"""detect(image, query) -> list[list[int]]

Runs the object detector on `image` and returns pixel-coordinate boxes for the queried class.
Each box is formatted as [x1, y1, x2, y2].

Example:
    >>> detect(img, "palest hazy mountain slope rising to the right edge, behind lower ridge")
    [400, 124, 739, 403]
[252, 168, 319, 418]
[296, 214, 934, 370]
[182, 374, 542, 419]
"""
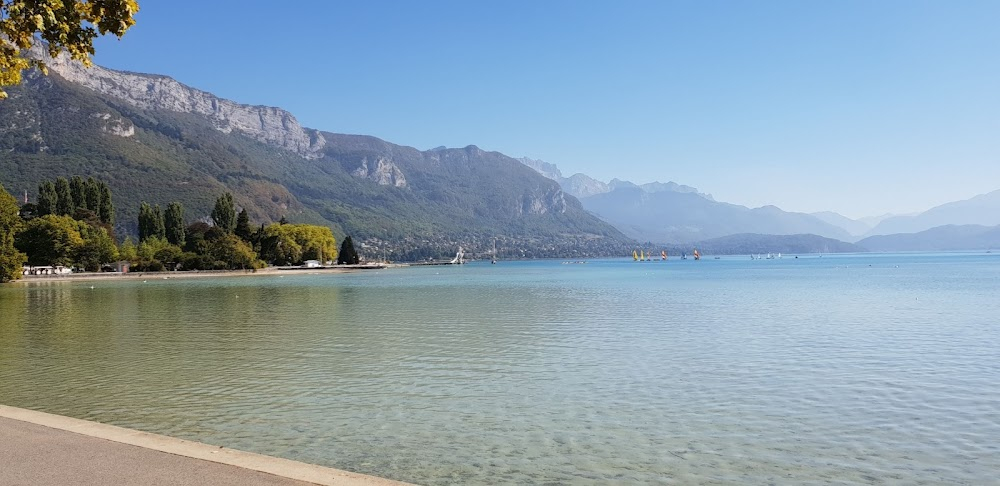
[868, 190, 1000, 236]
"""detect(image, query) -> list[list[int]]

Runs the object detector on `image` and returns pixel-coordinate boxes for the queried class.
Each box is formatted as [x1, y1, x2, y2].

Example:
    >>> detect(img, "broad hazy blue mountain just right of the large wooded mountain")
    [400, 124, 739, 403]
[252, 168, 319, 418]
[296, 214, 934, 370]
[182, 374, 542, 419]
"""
[580, 187, 851, 243]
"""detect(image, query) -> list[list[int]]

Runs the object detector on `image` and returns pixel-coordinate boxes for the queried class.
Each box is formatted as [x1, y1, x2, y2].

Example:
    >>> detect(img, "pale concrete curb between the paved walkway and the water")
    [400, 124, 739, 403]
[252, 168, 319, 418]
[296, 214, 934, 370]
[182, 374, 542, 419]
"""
[0, 405, 408, 486]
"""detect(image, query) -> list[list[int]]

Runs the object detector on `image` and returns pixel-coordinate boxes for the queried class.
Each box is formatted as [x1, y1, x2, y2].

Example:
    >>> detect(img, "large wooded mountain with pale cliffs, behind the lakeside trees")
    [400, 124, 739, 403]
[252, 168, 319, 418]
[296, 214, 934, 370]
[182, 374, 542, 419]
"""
[0, 43, 629, 259]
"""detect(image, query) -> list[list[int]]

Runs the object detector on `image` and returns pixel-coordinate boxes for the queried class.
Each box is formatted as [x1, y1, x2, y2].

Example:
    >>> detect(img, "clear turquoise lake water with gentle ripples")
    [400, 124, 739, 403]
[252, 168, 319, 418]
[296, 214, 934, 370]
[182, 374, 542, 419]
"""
[0, 254, 1000, 484]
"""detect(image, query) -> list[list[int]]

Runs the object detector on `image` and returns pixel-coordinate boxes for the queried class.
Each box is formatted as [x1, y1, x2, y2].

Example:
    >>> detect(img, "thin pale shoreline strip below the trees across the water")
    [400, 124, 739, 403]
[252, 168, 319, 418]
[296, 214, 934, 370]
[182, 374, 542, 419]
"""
[8, 263, 398, 284]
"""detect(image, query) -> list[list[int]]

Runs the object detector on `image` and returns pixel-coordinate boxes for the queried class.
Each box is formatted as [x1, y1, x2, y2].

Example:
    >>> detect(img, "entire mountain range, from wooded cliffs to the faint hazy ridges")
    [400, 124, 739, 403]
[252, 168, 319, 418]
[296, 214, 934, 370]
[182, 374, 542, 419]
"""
[0, 46, 1000, 259]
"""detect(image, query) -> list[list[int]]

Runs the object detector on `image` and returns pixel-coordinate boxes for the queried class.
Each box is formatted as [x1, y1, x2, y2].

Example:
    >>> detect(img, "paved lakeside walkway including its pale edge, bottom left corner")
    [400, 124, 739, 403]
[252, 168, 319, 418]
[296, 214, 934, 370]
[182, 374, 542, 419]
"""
[0, 405, 412, 486]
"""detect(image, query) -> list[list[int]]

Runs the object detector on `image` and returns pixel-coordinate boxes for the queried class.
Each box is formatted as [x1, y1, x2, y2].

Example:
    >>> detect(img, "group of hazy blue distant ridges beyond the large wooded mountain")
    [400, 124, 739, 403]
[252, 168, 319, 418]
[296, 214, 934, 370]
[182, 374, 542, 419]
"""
[519, 158, 1000, 251]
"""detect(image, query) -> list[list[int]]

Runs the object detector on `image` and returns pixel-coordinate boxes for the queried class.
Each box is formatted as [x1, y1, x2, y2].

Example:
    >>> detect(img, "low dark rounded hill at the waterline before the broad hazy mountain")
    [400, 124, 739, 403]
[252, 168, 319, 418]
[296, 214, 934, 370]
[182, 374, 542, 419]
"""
[693, 233, 865, 255]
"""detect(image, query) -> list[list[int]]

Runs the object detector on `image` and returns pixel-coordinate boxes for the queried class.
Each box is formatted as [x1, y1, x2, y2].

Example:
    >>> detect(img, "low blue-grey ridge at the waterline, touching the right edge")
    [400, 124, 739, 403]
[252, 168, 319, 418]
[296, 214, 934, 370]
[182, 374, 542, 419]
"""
[857, 224, 1000, 251]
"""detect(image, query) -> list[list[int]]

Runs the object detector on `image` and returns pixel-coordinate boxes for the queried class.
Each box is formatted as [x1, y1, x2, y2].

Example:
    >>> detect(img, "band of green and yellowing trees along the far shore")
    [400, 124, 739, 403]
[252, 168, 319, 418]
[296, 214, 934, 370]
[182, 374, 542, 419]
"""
[0, 177, 359, 282]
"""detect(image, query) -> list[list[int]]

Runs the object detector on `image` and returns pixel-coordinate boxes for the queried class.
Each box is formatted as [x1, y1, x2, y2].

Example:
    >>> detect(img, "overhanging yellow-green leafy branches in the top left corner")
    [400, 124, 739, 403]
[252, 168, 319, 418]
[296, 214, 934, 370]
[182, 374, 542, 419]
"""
[0, 0, 139, 99]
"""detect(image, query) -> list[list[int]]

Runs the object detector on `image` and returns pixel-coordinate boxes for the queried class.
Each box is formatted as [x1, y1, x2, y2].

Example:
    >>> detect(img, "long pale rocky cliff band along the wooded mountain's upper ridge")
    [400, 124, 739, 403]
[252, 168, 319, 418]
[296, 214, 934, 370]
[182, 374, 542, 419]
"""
[31, 45, 326, 159]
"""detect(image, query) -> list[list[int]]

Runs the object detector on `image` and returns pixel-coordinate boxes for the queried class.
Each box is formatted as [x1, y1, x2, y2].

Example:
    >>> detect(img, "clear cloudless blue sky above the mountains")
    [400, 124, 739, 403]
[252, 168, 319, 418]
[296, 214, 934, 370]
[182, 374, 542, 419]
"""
[95, 0, 1000, 217]
